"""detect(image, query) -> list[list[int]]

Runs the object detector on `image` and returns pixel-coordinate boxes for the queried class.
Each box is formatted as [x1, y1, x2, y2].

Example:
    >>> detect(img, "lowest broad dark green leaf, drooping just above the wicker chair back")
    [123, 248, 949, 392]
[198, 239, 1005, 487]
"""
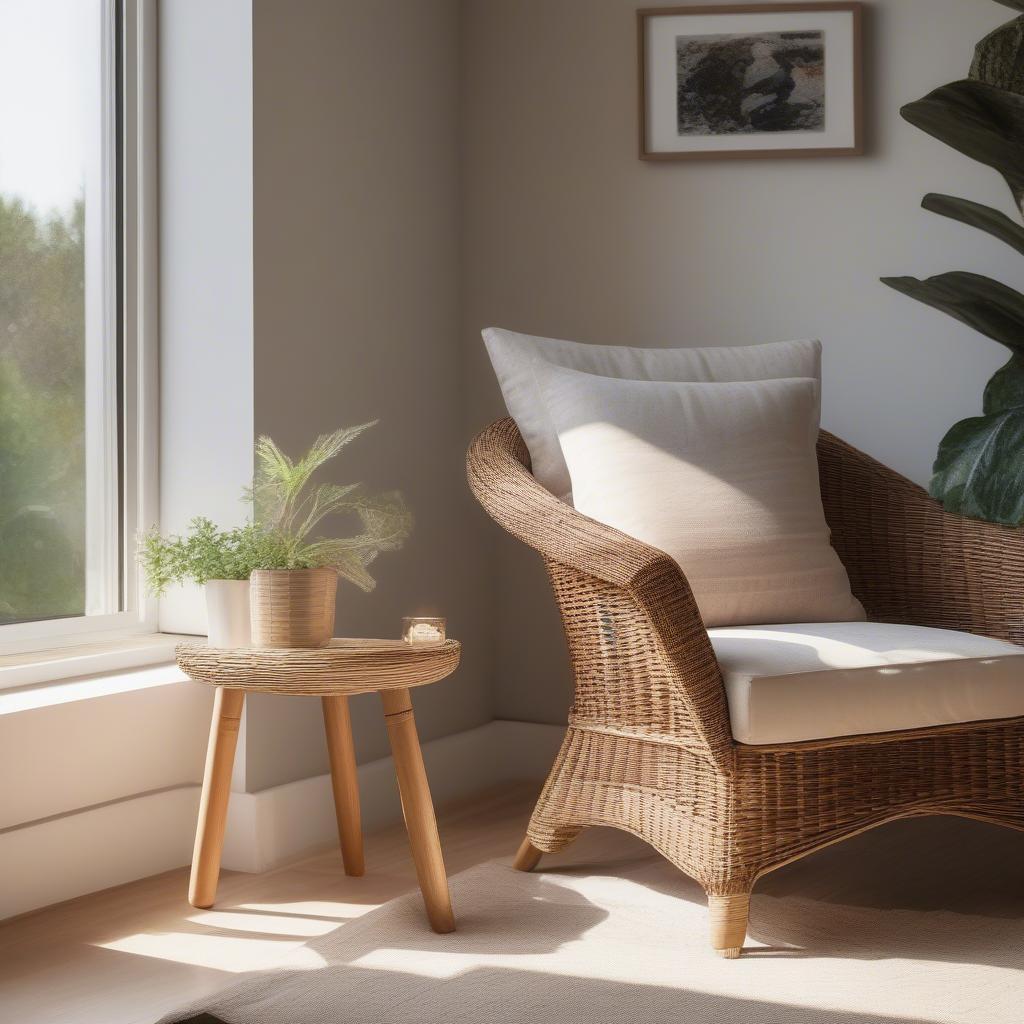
[930, 409, 1024, 526]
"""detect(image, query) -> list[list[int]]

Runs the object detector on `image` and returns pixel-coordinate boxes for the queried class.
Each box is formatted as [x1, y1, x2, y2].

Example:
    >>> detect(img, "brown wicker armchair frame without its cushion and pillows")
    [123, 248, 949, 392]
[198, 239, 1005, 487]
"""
[467, 420, 1024, 957]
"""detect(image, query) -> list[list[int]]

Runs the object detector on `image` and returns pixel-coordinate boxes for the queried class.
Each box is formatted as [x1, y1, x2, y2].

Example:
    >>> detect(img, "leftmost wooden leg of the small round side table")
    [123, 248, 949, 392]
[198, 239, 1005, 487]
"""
[188, 686, 246, 909]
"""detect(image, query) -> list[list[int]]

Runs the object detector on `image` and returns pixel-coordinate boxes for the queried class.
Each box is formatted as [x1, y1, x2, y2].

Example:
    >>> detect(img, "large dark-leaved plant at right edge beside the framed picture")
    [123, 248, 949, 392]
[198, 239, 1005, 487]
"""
[882, 0, 1024, 526]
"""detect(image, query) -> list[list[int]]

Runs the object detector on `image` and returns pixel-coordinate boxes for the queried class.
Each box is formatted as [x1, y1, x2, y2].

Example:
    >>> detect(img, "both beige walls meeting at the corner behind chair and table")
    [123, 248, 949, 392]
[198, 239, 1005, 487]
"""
[201, 0, 1013, 761]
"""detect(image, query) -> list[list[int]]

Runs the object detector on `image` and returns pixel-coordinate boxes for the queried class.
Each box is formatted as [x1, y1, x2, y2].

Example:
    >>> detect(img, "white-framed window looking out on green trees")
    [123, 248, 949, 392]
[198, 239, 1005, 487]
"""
[0, 0, 155, 653]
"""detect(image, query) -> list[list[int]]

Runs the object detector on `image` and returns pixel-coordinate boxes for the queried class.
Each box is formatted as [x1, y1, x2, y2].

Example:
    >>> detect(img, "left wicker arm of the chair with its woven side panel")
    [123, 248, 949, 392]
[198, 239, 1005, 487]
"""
[466, 420, 733, 770]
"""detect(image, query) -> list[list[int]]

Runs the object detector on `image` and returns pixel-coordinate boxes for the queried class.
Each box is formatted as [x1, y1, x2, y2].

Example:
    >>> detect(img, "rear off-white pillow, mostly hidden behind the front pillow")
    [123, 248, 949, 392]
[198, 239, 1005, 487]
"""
[482, 327, 821, 501]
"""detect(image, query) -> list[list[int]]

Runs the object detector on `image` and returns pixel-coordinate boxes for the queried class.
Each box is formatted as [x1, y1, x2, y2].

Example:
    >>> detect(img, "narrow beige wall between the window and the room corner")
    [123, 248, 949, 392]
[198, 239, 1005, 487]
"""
[246, 0, 493, 791]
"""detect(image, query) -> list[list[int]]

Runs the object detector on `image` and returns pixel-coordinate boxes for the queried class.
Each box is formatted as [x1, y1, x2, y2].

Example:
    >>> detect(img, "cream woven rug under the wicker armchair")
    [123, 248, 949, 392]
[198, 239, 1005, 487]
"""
[165, 819, 1024, 1024]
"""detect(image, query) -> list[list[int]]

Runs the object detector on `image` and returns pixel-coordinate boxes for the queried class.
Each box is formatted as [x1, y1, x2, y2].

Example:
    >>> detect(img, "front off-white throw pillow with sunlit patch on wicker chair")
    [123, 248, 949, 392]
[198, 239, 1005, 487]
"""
[536, 365, 864, 627]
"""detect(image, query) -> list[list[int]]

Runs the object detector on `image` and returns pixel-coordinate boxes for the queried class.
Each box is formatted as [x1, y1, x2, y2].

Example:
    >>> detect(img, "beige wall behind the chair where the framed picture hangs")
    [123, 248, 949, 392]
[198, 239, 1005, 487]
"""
[462, 0, 1017, 722]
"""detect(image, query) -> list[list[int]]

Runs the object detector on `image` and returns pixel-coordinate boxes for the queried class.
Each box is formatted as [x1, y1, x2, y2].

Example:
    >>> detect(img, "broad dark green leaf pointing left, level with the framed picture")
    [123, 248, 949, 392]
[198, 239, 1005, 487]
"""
[900, 79, 1024, 206]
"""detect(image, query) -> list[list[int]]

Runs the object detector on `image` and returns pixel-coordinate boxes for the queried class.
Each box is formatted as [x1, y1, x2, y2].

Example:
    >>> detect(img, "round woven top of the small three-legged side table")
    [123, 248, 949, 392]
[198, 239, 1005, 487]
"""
[175, 637, 462, 696]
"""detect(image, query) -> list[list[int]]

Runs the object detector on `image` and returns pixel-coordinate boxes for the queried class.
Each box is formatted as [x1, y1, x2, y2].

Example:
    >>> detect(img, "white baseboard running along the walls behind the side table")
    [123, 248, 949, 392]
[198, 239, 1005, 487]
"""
[0, 721, 565, 920]
